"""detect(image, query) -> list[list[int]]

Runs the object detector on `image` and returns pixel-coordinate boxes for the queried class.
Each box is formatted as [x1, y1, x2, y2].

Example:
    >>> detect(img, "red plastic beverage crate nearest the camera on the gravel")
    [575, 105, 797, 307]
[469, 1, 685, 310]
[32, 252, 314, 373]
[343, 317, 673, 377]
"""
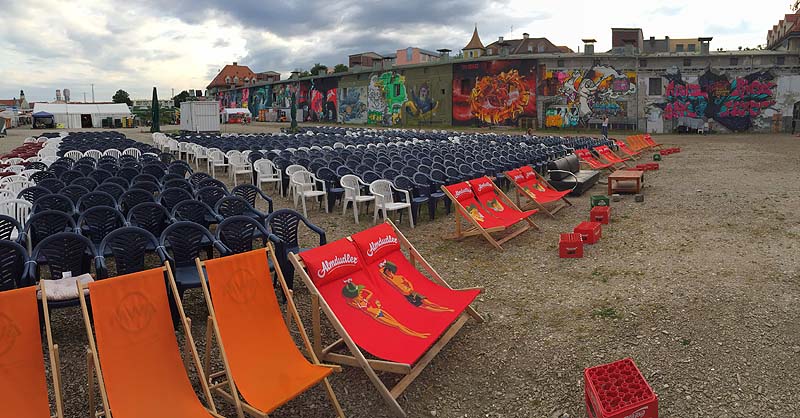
[583, 358, 658, 418]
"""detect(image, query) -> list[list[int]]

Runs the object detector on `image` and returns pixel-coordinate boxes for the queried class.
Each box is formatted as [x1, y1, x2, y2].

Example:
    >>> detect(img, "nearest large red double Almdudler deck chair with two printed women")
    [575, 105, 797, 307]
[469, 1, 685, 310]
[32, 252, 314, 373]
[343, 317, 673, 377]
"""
[289, 221, 483, 417]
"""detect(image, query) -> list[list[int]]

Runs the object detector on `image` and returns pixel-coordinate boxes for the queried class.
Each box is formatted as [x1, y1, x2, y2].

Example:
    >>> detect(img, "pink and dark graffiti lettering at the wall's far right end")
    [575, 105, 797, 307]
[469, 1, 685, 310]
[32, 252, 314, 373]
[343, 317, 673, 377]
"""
[657, 70, 777, 131]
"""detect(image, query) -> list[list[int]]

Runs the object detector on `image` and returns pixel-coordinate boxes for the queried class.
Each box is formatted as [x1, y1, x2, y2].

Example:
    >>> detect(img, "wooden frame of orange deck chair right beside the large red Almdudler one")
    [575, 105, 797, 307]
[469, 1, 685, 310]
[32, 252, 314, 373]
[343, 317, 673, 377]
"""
[195, 243, 345, 418]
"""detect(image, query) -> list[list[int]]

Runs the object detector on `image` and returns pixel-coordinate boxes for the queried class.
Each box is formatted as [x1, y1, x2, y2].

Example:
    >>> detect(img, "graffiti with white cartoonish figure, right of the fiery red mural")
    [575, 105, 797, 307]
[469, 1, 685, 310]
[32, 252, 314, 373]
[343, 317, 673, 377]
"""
[542, 66, 636, 128]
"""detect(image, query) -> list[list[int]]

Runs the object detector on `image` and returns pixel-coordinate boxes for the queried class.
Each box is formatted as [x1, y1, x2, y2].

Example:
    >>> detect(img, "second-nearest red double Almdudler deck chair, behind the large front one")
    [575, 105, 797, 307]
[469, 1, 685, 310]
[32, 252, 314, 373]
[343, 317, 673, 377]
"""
[442, 182, 530, 251]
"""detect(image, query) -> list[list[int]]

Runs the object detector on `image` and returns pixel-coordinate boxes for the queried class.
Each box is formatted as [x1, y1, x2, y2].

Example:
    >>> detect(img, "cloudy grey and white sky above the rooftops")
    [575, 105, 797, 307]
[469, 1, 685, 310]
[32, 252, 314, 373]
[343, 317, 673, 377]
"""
[0, 0, 790, 101]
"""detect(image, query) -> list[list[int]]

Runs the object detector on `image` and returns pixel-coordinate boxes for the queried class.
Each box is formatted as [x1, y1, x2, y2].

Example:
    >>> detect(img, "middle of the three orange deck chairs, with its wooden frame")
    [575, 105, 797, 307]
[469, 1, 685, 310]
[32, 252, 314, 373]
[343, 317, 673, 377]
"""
[78, 263, 221, 418]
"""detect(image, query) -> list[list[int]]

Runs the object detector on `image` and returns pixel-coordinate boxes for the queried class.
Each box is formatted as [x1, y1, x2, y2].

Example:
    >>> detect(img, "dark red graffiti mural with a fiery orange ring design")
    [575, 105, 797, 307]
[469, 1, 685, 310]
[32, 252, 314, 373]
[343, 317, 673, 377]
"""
[453, 60, 536, 126]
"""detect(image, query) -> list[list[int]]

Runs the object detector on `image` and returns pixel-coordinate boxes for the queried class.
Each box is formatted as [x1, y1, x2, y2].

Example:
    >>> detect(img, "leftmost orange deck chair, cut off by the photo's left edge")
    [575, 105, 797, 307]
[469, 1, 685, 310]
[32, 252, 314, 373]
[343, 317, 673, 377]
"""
[0, 280, 64, 418]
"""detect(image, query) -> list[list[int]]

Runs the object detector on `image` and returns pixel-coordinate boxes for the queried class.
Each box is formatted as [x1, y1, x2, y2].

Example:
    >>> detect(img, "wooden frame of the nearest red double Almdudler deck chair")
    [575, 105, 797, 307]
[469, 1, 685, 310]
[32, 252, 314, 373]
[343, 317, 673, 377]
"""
[289, 220, 483, 417]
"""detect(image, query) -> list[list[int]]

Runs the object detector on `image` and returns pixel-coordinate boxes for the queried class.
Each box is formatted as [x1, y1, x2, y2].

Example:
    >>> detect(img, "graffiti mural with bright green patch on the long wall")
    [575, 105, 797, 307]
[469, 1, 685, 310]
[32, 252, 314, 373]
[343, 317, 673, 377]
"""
[367, 71, 408, 125]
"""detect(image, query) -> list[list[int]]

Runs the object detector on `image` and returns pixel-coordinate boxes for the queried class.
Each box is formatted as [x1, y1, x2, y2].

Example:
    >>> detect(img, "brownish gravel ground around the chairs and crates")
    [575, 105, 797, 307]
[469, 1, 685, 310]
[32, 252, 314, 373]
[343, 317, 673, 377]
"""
[0, 126, 800, 417]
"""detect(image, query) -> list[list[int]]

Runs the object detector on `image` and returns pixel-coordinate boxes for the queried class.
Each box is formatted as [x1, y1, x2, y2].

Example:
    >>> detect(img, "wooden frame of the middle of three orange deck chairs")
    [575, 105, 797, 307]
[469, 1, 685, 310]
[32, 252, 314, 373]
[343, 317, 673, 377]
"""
[77, 261, 225, 418]
